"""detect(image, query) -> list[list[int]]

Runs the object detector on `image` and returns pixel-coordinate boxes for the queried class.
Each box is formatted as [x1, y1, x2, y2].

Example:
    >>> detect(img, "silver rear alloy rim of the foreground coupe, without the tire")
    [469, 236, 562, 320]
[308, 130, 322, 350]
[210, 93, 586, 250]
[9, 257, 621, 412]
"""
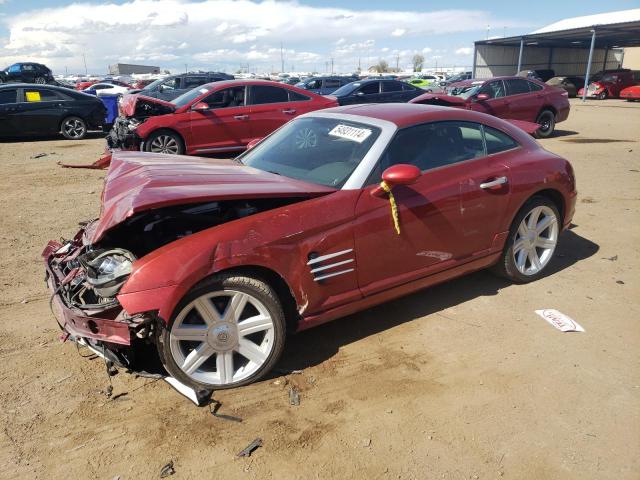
[513, 205, 559, 276]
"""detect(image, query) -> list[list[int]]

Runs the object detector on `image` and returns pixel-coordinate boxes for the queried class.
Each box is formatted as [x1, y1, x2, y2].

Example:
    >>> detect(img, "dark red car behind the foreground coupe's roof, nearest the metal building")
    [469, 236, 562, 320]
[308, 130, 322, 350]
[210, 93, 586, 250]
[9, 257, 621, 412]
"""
[409, 77, 570, 138]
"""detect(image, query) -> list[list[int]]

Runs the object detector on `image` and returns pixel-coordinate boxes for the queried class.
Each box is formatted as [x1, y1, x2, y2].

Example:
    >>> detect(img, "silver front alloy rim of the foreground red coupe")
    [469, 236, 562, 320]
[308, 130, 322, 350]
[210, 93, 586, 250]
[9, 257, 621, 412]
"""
[169, 290, 275, 385]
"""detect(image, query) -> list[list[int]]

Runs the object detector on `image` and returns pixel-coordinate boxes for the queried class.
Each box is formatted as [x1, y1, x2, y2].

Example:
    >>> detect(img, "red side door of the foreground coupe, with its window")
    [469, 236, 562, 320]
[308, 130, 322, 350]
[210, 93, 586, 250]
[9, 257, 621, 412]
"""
[354, 121, 509, 296]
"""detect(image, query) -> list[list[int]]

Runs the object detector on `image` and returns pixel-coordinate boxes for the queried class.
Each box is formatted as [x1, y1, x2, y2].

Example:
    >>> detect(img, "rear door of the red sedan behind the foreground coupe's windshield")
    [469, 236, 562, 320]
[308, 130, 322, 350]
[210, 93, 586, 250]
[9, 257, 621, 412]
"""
[249, 85, 296, 137]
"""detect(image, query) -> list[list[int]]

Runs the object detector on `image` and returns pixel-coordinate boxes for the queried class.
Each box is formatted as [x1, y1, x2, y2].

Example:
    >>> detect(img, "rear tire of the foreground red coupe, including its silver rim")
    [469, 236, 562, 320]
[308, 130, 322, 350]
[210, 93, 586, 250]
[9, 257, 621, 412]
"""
[493, 196, 561, 283]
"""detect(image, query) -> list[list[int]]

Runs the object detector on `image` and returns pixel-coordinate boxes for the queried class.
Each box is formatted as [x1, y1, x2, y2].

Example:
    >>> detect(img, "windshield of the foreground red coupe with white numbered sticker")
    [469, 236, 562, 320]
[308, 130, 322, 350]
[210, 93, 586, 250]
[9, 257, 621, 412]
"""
[238, 117, 380, 188]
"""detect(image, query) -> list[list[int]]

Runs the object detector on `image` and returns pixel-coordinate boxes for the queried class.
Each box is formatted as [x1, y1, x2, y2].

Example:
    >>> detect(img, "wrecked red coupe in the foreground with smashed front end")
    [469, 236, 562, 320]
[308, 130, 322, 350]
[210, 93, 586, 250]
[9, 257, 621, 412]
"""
[43, 104, 576, 389]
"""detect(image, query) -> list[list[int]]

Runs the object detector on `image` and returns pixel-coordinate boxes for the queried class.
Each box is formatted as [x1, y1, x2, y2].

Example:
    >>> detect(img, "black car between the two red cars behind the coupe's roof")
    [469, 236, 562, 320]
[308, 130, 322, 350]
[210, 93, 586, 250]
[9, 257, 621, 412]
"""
[332, 79, 424, 105]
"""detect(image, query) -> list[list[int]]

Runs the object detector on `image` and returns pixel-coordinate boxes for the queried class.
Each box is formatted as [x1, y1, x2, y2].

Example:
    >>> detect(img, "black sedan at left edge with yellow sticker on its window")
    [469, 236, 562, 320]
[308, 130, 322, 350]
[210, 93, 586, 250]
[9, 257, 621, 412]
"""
[0, 83, 106, 140]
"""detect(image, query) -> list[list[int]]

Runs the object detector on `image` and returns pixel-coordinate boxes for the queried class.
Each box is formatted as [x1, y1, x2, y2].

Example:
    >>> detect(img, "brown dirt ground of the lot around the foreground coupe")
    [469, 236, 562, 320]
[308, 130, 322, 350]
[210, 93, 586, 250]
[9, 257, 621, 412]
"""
[0, 100, 640, 480]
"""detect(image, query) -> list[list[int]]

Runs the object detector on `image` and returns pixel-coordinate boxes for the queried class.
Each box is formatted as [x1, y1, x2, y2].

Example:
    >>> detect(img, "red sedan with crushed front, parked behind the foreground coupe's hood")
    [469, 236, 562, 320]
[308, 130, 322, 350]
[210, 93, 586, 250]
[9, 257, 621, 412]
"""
[107, 80, 338, 155]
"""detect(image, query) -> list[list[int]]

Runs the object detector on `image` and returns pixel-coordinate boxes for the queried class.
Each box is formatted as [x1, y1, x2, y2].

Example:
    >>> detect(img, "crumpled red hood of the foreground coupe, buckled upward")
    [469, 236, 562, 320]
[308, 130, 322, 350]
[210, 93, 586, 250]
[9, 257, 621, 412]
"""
[87, 152, 335, 243]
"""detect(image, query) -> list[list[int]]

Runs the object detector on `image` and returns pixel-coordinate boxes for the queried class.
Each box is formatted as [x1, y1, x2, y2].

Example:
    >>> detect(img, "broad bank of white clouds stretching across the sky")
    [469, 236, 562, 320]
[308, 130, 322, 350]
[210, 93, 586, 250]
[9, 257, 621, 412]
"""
[0, 0, 519, 72]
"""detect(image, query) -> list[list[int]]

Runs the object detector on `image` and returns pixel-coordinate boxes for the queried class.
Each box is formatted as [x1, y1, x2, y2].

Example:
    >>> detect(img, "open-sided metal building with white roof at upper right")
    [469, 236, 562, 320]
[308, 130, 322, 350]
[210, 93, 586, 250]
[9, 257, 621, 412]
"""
[473, 8, 640, 96]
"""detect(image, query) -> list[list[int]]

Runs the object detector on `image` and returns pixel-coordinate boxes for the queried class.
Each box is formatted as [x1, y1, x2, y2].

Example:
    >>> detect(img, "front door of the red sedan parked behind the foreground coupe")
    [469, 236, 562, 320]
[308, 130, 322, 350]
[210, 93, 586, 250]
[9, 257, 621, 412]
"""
[182, 85, 254, 153]
